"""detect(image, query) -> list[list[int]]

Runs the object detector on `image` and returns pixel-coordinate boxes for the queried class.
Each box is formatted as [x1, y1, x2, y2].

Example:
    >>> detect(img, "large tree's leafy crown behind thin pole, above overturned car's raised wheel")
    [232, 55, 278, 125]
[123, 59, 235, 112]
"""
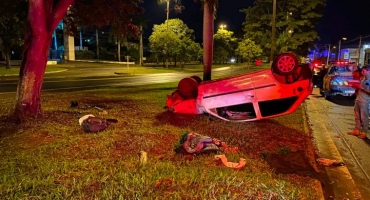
[241, 0, 326, 59]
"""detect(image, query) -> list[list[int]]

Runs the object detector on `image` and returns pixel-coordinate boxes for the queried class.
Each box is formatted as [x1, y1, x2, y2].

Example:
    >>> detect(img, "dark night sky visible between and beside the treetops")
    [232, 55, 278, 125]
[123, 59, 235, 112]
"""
[142, 0, 370, 44]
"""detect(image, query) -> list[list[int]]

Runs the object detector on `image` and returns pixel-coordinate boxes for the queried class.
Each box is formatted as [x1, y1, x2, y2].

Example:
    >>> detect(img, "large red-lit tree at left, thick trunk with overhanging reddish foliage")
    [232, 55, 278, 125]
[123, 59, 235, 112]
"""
[14, 0, 141, 120]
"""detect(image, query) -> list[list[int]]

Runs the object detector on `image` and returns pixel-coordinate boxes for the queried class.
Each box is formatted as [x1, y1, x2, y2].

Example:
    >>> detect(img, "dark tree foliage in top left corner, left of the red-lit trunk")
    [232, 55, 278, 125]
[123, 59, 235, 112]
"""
[0, 0, 27, 69]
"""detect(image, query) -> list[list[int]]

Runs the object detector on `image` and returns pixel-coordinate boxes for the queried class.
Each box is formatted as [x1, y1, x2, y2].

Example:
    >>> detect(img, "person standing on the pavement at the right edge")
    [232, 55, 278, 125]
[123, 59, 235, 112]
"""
[348, 66, 370, 139]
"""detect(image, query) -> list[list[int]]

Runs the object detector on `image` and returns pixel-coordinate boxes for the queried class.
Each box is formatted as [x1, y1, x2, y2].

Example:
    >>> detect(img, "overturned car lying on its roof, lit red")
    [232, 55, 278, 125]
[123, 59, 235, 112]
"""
[166, 53, 313, 122]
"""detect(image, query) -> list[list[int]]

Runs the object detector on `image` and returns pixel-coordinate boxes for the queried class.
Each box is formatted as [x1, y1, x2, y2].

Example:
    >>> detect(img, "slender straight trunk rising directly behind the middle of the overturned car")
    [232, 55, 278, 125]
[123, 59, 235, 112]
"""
[203, 1, 214, 81]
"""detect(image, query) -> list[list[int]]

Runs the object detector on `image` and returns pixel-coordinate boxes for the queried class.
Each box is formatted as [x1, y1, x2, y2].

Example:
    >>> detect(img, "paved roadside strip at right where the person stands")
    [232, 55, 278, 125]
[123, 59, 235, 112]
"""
[306, 88, 370, 200]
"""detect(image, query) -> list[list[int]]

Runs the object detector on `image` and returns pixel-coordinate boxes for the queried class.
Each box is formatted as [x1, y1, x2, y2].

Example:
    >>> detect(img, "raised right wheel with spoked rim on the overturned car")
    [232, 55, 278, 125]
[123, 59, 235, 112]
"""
[272, 53, 299, 76]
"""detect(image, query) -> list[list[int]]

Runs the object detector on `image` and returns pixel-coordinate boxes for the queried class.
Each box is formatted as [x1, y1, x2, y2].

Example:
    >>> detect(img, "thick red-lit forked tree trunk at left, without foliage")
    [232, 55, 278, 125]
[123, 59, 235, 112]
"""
[14, 0, 74, 121]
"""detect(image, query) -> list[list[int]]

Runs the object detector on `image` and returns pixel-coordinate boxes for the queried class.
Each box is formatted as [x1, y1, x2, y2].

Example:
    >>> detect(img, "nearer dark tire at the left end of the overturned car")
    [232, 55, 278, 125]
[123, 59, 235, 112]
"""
[177, 77, 198, 99]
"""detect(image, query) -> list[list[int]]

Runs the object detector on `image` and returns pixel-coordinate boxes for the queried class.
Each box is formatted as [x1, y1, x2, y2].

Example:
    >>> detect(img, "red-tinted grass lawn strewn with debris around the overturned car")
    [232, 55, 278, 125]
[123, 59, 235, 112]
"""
[0, 83, 321, 200]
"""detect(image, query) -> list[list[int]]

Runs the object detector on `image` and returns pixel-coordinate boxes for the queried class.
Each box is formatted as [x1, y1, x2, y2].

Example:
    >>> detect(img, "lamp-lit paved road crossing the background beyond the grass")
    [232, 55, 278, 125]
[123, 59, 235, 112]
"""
[0, 67, 246, 94]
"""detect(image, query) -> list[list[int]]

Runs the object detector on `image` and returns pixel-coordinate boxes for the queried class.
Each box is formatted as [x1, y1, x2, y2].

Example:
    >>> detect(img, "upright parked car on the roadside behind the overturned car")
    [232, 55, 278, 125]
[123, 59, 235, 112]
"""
[320, 61, 360, 100]
